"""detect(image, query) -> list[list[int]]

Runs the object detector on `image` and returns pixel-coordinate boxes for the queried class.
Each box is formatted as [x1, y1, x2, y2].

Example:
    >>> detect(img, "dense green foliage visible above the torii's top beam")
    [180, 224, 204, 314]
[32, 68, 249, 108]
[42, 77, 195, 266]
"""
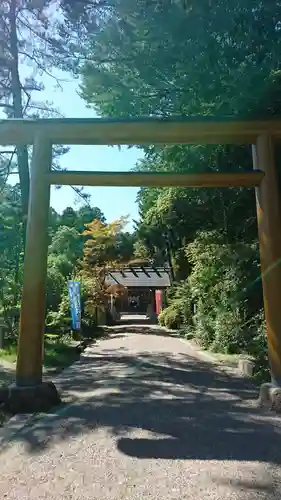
[82, 0, 281, 117]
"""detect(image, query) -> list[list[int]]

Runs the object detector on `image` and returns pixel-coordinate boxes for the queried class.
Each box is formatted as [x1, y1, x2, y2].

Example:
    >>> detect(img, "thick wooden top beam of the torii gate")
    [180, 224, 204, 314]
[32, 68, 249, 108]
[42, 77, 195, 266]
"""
[0, 117, 281, 146]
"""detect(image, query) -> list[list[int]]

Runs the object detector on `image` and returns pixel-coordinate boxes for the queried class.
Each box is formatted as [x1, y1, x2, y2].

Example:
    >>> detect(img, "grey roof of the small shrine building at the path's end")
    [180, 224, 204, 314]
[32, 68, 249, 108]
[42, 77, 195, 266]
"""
[105, 266, 171, 288]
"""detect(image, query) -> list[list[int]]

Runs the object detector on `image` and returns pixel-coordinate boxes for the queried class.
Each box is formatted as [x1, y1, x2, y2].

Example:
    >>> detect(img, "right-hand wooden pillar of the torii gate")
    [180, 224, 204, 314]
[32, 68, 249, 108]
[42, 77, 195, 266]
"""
[253, 134, 281, 396]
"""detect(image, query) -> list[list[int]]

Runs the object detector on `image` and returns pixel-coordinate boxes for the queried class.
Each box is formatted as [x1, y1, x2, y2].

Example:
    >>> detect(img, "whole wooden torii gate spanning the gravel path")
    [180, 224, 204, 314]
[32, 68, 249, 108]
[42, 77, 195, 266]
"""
[0, 117, 281, 411]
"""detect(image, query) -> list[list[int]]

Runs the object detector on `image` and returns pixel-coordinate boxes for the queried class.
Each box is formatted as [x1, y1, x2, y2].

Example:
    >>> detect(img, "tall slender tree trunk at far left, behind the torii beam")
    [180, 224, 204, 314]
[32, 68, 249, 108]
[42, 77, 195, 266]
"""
[9, 0, 29, 225]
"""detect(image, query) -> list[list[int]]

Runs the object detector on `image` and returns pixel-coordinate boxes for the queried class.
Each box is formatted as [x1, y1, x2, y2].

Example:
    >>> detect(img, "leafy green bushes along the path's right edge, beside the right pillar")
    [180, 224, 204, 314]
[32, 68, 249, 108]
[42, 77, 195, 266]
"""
[159, 232, 269, 382]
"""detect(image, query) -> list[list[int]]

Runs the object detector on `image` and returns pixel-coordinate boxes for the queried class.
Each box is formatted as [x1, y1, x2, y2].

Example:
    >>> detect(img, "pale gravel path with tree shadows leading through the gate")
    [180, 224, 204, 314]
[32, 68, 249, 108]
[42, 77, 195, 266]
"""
[0, 333, 281, 500]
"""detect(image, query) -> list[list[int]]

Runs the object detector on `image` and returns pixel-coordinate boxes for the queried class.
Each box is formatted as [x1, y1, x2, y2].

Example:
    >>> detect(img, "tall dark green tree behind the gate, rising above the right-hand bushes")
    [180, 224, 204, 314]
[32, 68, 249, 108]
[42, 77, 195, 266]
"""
[74, 0, 264, 274]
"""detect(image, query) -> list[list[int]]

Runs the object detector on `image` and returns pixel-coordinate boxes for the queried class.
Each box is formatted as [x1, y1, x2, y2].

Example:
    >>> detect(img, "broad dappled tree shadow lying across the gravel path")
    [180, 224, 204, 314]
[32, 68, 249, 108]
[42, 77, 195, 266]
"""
[1, 338, 281, 465]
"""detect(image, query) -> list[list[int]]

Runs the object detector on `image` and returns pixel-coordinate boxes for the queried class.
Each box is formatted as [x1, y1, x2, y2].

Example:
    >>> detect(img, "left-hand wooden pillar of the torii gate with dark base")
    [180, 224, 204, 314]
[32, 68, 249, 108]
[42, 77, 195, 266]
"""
[9, 134, 60, 412]
